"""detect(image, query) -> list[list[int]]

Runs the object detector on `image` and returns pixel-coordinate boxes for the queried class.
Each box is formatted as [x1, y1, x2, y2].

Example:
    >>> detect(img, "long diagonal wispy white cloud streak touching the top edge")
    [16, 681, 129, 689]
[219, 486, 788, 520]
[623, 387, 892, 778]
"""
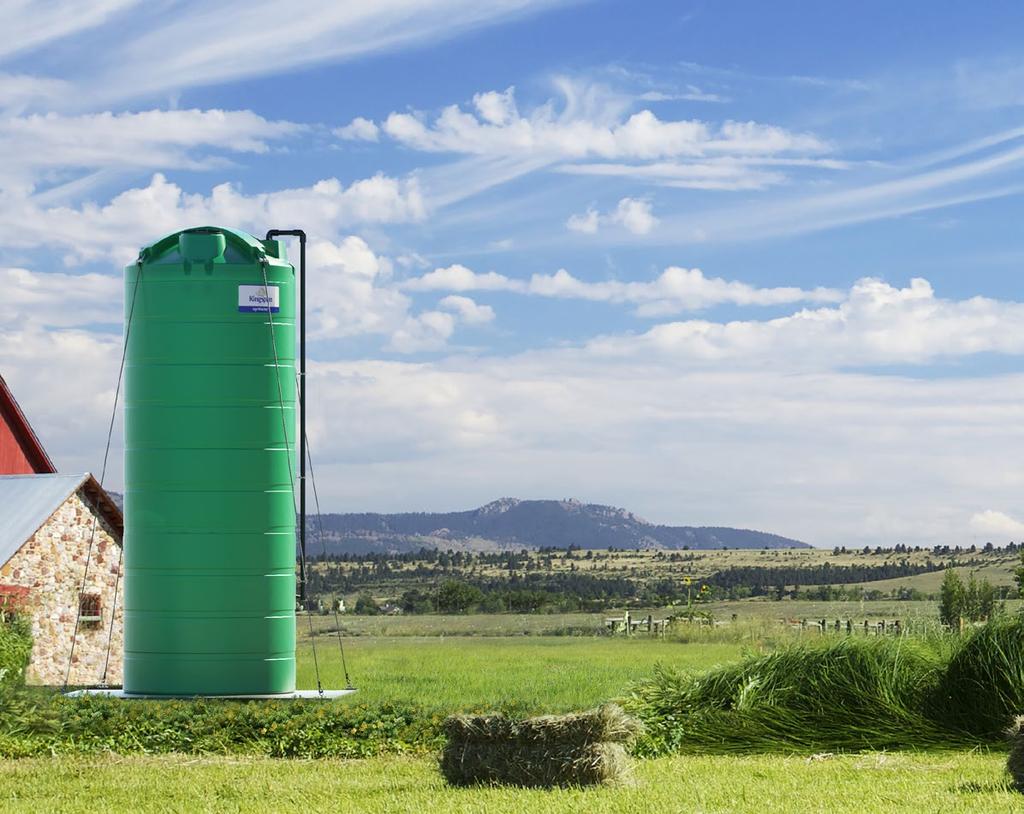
[72, 0, 577, 106]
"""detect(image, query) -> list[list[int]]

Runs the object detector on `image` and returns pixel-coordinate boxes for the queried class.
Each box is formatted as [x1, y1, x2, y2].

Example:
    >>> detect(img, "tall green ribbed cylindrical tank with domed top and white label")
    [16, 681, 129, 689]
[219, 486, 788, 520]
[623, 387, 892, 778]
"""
[124, 227, 297, 695]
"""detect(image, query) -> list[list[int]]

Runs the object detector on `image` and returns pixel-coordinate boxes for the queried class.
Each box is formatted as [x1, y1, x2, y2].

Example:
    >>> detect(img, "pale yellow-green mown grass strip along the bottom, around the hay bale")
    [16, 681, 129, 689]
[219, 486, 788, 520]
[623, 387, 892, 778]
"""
[0, 753, 1024, 814]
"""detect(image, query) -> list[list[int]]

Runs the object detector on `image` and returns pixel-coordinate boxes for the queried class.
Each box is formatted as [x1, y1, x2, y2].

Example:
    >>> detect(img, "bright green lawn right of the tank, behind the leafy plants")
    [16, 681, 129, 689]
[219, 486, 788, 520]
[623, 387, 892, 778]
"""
[298, 636, 741, 714]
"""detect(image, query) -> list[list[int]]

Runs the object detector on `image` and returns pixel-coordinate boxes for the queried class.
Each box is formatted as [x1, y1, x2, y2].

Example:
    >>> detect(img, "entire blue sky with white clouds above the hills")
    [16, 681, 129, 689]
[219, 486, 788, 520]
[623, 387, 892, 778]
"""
[0, 0, 1024, 546]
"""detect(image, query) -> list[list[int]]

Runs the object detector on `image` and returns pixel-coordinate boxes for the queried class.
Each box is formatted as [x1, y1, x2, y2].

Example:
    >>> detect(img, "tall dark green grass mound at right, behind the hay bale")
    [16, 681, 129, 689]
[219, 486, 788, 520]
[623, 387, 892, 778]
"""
[629, 616, 1024, 755]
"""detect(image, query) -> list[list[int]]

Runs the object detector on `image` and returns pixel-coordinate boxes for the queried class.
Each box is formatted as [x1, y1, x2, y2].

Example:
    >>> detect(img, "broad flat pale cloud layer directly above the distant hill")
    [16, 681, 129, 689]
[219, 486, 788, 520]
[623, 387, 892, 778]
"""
[310, 349, 1024, 546]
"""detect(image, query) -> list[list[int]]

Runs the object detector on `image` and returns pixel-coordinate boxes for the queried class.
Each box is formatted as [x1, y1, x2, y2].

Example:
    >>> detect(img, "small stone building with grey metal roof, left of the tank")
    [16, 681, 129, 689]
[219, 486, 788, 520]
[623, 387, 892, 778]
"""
[0, 474, 124, 686]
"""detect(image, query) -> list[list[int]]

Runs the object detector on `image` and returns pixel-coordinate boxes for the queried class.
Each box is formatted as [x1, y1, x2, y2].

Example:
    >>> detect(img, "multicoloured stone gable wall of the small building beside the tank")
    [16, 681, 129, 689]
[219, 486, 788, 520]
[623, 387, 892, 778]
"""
[0, 489, 124, 685]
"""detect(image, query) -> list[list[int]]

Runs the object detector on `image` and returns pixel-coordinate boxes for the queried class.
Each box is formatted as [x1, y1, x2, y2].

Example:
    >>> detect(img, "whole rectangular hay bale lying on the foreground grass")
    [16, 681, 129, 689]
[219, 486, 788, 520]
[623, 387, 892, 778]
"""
[440, 704, 640, 787]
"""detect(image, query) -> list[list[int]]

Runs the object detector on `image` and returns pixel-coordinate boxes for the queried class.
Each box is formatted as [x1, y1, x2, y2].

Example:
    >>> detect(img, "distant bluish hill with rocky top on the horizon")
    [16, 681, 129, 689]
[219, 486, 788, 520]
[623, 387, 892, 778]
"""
[307, 498, 810, 557]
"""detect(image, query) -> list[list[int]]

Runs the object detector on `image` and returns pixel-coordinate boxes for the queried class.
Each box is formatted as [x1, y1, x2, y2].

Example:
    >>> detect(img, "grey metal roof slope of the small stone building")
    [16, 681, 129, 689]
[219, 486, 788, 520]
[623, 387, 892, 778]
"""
[0, 473, 91, 565]
